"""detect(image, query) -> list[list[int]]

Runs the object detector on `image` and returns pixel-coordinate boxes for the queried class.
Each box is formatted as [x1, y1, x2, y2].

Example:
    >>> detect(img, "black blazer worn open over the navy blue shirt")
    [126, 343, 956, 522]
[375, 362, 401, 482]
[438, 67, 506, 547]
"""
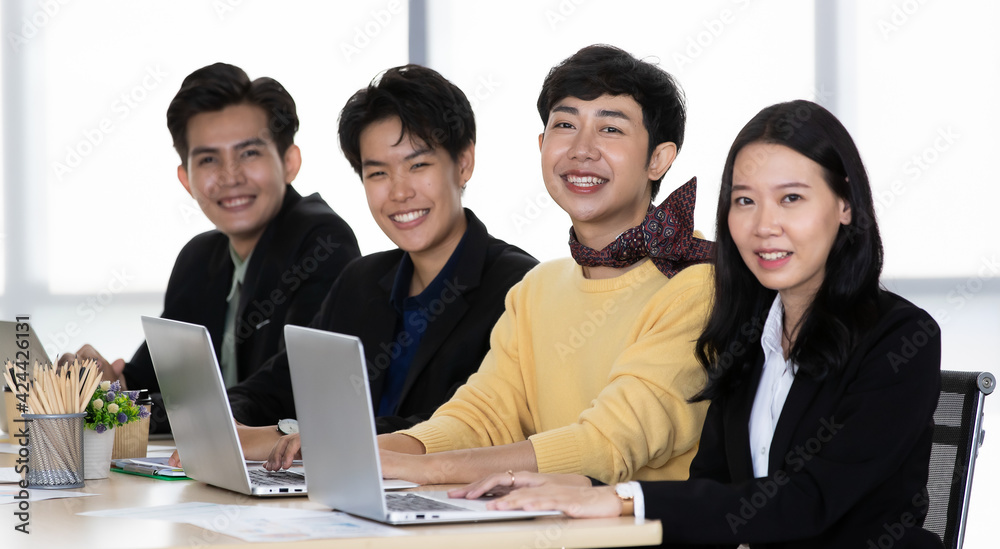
[229, 209, 536, 433]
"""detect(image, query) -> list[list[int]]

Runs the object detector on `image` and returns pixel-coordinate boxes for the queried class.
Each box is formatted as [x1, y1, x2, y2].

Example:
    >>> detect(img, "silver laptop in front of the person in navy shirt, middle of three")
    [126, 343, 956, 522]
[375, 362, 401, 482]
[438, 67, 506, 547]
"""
[142, 316, 306, 496]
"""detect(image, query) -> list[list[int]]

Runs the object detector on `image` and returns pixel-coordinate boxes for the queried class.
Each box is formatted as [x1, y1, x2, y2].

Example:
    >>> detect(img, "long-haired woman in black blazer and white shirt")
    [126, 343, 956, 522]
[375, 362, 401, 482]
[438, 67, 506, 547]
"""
[453, 101, 941, 549]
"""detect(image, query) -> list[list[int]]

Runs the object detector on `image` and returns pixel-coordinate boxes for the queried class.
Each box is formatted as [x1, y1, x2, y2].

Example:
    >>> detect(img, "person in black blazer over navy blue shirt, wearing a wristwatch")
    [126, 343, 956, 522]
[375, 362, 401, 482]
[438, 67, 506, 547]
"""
[229, 65, 537, 468]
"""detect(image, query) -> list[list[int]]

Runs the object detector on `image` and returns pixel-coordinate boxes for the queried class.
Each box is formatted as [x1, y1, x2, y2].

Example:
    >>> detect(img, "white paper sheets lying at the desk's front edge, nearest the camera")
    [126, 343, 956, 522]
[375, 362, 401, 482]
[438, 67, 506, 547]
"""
[79, 501, 408, 542]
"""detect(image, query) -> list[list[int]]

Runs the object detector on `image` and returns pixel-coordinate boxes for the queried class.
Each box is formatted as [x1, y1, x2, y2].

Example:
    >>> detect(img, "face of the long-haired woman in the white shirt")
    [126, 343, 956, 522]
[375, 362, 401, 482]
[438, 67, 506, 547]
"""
[729, 143, 851, 306]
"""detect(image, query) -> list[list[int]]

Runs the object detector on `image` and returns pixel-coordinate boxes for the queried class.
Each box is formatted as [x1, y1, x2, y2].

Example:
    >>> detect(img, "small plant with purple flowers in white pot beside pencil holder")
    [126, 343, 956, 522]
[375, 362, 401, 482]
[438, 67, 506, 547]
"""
[83, 381, 149, 480]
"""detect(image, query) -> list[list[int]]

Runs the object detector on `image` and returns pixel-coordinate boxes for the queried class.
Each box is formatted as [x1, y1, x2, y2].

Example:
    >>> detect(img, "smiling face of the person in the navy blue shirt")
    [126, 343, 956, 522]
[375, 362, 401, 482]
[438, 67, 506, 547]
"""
[359, 117, 475, 269]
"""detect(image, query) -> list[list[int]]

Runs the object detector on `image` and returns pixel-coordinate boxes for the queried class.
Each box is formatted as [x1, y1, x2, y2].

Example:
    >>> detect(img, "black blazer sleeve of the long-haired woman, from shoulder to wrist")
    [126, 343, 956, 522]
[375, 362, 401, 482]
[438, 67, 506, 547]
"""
[641, 306, 941, 544]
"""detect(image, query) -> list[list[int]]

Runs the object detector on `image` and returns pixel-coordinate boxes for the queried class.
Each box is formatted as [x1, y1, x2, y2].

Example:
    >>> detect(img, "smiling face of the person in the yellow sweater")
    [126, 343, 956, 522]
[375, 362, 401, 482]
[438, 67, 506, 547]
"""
[538, 95, 677, 249]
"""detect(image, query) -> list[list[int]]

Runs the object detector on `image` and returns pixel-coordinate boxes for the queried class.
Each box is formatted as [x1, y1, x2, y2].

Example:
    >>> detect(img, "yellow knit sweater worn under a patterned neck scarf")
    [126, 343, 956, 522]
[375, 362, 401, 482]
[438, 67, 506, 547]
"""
[403, 258, 712, 483]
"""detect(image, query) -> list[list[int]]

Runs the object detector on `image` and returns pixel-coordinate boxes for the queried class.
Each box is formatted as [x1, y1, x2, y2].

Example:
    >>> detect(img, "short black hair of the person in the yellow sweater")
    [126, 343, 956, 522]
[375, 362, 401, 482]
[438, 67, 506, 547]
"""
[538, 44, 687, 197]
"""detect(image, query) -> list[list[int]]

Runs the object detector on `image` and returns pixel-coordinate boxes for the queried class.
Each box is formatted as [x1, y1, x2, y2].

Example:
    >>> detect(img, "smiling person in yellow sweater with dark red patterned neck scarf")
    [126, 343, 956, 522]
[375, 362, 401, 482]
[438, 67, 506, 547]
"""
[269, 46, 712, 484]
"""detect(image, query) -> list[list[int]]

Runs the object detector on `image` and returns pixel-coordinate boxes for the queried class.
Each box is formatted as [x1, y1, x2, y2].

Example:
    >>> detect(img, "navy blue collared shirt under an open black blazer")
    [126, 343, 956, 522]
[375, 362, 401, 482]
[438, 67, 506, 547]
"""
[376, 229, 469, 416]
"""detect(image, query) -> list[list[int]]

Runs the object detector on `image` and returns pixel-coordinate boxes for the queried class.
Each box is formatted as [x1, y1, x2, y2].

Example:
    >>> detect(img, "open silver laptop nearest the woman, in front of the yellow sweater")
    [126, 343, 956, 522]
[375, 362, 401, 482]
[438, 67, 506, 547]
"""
[285, 325, 560, 524]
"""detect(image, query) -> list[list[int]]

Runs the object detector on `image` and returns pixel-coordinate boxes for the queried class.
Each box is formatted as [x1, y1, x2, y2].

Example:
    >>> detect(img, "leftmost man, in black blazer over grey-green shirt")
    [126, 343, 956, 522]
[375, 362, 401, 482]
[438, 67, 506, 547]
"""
[58, 63, 360, 431]
